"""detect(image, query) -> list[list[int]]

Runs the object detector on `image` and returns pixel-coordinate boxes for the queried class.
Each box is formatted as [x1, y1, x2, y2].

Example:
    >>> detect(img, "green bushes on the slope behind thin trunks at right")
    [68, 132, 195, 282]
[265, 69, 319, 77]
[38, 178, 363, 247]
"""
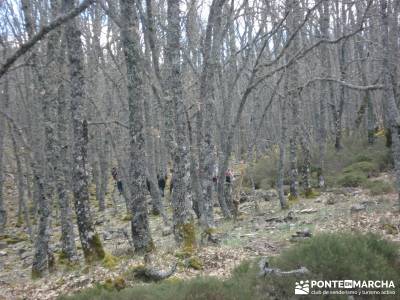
[243, 136, 393, 189]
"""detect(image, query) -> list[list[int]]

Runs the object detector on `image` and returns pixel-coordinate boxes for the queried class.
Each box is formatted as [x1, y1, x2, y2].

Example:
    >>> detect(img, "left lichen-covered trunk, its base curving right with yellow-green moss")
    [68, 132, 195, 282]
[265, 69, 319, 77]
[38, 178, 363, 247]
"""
[63, 0, 104, 262]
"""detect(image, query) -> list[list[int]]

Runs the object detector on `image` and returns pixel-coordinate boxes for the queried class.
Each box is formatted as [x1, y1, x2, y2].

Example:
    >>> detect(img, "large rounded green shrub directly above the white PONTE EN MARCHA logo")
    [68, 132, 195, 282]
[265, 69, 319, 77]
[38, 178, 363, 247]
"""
[273, 233, 400, 280]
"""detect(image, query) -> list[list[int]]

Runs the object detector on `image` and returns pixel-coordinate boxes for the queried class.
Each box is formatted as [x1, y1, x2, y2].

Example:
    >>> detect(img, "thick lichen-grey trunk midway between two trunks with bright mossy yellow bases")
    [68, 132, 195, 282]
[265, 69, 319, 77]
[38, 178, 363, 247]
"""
[120, 0, 154, 253]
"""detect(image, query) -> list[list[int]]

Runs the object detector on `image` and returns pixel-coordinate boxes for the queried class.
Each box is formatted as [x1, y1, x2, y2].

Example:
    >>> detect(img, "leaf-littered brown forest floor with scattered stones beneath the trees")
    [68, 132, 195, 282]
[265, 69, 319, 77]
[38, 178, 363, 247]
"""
[0, 173, 400, 300]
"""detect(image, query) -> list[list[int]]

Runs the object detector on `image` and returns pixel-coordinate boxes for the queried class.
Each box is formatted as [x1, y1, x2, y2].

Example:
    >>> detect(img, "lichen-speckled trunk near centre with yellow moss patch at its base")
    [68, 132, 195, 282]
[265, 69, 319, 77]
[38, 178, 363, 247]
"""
[166, 0, 196, 251]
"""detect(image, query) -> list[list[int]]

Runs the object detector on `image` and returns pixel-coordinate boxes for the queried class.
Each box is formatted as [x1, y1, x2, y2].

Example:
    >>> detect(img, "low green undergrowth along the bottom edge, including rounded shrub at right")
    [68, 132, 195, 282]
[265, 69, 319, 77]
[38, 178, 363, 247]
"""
[60, 233, 400, 300]
